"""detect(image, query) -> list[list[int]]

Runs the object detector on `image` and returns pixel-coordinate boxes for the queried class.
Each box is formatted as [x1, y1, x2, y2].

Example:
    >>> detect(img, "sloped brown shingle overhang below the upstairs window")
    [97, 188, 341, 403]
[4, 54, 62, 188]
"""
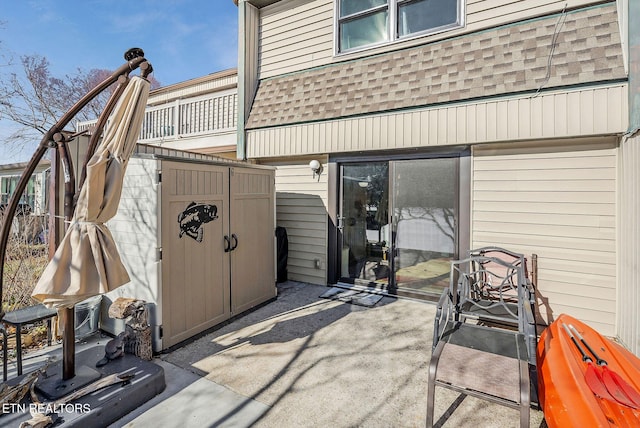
[246, 3, 626, 129]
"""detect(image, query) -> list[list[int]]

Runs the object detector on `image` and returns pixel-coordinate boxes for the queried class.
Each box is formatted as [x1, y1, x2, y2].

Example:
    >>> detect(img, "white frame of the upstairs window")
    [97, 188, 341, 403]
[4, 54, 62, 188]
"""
[333, 0, 466, 56]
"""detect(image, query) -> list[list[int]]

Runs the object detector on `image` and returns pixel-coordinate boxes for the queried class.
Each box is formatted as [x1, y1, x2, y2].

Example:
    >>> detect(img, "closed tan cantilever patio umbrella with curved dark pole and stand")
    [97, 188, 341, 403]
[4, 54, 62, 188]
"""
[0, 48, 153, 388]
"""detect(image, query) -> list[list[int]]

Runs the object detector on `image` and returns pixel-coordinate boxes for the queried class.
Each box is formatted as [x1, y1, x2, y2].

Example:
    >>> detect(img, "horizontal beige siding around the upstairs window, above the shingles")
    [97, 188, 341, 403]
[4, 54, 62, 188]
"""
[258, 0, 596, 79]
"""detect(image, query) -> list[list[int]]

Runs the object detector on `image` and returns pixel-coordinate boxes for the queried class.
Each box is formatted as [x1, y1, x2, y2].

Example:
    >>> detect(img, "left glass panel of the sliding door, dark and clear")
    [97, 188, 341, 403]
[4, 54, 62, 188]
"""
[338, 162, 390, 284]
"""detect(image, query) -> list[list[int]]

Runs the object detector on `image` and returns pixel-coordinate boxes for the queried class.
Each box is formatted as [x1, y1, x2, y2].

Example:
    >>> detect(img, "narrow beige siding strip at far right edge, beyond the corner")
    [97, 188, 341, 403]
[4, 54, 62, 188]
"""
[618, 132, 640, 356]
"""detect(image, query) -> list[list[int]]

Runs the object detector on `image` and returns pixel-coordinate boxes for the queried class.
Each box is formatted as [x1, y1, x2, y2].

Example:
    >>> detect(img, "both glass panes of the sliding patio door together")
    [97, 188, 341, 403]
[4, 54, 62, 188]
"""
[338, 157, 458, 297]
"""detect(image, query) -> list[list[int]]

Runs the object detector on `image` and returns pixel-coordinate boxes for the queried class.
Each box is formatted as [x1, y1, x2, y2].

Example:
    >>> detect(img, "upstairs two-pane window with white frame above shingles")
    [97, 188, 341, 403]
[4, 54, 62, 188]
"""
[336, 0, 464, 53]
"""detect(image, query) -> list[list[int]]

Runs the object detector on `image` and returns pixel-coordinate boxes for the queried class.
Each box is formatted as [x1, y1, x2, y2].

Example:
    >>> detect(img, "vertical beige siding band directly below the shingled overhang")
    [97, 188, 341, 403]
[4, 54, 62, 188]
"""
[247, 84, 628, 158]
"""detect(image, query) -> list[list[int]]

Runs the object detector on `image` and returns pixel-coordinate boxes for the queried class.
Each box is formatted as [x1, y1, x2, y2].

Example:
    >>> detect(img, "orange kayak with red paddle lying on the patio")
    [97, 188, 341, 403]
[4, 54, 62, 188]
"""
[536, 314, 640, 428]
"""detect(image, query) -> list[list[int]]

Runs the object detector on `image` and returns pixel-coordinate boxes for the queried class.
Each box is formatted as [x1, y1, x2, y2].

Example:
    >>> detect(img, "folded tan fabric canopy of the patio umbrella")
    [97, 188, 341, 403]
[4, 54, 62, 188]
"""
[32, 76, 149, 309]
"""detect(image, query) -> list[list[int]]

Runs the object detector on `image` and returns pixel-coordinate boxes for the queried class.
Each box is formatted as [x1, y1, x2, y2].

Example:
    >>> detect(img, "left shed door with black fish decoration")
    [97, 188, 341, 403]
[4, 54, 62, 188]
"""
[161, 162, 230, 348]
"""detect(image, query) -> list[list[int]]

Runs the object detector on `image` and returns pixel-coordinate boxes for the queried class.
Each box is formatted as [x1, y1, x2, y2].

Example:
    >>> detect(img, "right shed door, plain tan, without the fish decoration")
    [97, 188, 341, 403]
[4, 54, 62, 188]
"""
[230, 168, 276, 315]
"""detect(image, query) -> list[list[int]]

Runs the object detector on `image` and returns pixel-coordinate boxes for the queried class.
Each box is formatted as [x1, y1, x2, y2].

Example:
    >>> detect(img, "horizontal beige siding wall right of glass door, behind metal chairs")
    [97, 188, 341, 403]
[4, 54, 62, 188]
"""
[471, 140, 617, 336]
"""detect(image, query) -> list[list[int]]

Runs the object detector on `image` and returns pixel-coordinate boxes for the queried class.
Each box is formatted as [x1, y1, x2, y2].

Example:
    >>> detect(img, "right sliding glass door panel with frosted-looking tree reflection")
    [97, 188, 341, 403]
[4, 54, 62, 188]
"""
[392, 158, 458, 295]
